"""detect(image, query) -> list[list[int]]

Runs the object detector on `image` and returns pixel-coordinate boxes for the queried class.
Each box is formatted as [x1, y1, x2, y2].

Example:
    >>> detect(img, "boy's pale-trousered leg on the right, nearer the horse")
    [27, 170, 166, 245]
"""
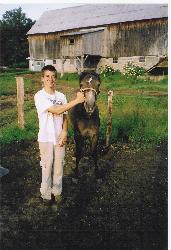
[52, 145, 65, 196]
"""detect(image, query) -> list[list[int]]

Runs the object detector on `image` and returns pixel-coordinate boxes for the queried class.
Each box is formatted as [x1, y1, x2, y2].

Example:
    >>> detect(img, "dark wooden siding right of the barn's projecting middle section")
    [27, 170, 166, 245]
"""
[105, 18, 168, 57]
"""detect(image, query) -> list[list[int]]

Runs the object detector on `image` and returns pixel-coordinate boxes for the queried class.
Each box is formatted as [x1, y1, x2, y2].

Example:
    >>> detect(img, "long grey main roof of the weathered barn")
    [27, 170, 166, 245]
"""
[27, 4, 168, 35]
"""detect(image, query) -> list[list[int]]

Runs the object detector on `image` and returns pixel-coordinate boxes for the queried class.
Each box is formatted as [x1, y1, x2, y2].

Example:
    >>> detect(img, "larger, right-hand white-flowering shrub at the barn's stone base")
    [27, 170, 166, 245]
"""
[123, 62, 145, 79]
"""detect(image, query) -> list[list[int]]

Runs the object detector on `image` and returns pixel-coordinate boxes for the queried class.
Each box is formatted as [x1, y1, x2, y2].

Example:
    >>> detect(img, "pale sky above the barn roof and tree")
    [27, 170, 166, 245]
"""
[0, 0, 167, 20]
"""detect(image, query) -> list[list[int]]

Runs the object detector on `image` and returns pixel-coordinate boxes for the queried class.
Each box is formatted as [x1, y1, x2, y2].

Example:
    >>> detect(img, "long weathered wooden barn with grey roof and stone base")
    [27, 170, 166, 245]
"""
[27, 4, 168, 73]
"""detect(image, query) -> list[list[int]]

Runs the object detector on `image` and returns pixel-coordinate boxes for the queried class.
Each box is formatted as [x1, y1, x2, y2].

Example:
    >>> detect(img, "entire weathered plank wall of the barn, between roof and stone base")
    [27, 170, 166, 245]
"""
[28, 18, 168, 59]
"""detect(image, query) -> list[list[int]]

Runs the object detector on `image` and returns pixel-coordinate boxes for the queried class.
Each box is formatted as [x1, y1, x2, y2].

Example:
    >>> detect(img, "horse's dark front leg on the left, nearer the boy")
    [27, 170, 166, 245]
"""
[74, 132, 84, 177]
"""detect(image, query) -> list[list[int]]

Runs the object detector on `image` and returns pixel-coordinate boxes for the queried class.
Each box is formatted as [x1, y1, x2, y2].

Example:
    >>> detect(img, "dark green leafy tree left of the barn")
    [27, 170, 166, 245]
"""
[0, 7, 35, 66]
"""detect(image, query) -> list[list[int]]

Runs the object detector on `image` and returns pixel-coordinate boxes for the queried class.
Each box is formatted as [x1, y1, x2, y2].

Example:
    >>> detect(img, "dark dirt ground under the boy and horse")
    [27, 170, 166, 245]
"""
[1, 141, 167, 250]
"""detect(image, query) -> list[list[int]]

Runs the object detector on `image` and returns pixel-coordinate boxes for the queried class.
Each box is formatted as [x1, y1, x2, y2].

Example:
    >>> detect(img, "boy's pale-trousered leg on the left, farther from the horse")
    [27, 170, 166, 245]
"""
[39, 142, 53, 200]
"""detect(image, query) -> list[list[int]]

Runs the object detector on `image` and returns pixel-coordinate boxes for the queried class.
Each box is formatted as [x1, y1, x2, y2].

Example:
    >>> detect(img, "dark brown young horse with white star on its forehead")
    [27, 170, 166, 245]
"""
[70, 72, 101, 177]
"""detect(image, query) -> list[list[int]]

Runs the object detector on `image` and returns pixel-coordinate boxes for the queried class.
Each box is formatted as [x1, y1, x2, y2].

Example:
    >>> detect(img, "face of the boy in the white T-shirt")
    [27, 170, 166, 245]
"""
[42, 70, 56, 89]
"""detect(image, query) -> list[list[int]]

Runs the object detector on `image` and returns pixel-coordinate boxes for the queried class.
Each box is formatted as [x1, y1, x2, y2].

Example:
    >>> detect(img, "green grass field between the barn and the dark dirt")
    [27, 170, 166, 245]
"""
[0, 72, 168, 147]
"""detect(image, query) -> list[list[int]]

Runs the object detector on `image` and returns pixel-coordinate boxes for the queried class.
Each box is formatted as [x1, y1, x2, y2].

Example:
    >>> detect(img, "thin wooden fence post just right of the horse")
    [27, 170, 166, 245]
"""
[106, 90, 113, 146]
